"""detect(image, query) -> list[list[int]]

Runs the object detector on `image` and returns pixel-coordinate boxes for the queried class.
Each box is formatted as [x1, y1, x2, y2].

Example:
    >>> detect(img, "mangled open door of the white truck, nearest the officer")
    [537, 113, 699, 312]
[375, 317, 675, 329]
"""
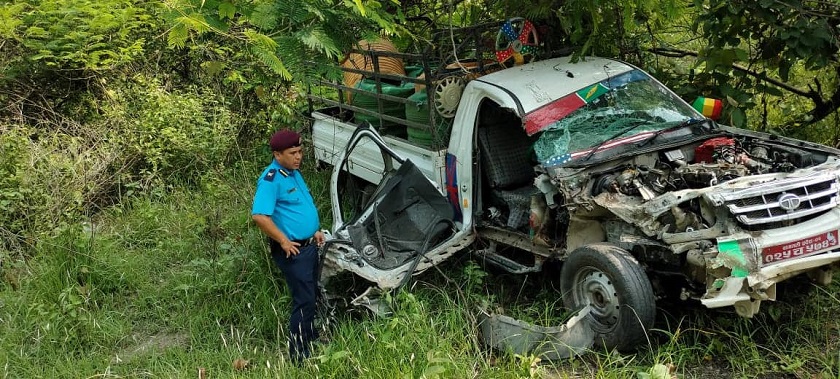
[320, 127, 473, 290]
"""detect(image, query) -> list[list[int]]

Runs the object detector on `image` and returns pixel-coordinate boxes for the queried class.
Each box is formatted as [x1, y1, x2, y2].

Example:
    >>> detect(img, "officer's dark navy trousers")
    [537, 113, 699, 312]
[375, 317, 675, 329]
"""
[271, 240, 318, 362]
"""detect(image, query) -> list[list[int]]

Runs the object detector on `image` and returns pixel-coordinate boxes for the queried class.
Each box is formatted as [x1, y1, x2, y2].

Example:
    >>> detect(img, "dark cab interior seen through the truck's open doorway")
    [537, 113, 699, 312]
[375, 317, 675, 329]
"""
[476, 99, 539, 232]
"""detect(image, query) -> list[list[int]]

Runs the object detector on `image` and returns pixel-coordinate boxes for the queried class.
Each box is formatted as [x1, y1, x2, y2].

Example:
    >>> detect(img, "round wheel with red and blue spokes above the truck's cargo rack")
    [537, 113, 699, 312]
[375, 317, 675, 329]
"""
[496, 17, 540, 66]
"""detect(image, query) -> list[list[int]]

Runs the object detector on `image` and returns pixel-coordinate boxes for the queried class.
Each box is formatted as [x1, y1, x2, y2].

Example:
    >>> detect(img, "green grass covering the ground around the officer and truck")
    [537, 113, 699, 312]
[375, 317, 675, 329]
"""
[0, 162, 840, 379]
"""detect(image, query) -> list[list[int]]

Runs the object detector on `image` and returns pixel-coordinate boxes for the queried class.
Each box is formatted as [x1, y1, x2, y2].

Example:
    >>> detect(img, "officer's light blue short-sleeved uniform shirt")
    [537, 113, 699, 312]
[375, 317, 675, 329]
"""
[251, 159, 321, 240]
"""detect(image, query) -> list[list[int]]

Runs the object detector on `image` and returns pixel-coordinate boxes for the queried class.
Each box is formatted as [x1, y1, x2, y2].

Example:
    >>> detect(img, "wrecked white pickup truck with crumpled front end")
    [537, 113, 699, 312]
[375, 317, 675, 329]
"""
[312, 45, 840, 356]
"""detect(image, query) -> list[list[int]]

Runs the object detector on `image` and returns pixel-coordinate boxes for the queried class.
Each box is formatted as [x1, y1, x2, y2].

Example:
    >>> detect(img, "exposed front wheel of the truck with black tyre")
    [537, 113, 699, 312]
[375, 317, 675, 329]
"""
[560, 244, 656, 351]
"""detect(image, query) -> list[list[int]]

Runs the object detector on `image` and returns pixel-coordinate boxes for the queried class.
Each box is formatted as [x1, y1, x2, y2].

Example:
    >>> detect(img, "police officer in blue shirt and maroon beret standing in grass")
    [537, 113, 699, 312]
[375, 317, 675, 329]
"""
[251, 130, 324, 363]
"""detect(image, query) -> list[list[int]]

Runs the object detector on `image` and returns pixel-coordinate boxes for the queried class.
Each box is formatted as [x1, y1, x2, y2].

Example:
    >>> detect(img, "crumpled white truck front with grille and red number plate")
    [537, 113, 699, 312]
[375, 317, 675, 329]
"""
[593, 163, 840, 317]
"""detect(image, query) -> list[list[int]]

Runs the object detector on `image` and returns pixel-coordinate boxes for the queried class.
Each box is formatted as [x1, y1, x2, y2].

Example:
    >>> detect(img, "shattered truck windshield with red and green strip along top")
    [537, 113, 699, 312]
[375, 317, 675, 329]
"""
[526, 70, 702, 166]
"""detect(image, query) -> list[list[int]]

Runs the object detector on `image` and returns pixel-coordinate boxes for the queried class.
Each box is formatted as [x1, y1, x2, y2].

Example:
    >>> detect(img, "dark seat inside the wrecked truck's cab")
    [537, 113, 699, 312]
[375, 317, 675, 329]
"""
[478, 120, 538, 229]
